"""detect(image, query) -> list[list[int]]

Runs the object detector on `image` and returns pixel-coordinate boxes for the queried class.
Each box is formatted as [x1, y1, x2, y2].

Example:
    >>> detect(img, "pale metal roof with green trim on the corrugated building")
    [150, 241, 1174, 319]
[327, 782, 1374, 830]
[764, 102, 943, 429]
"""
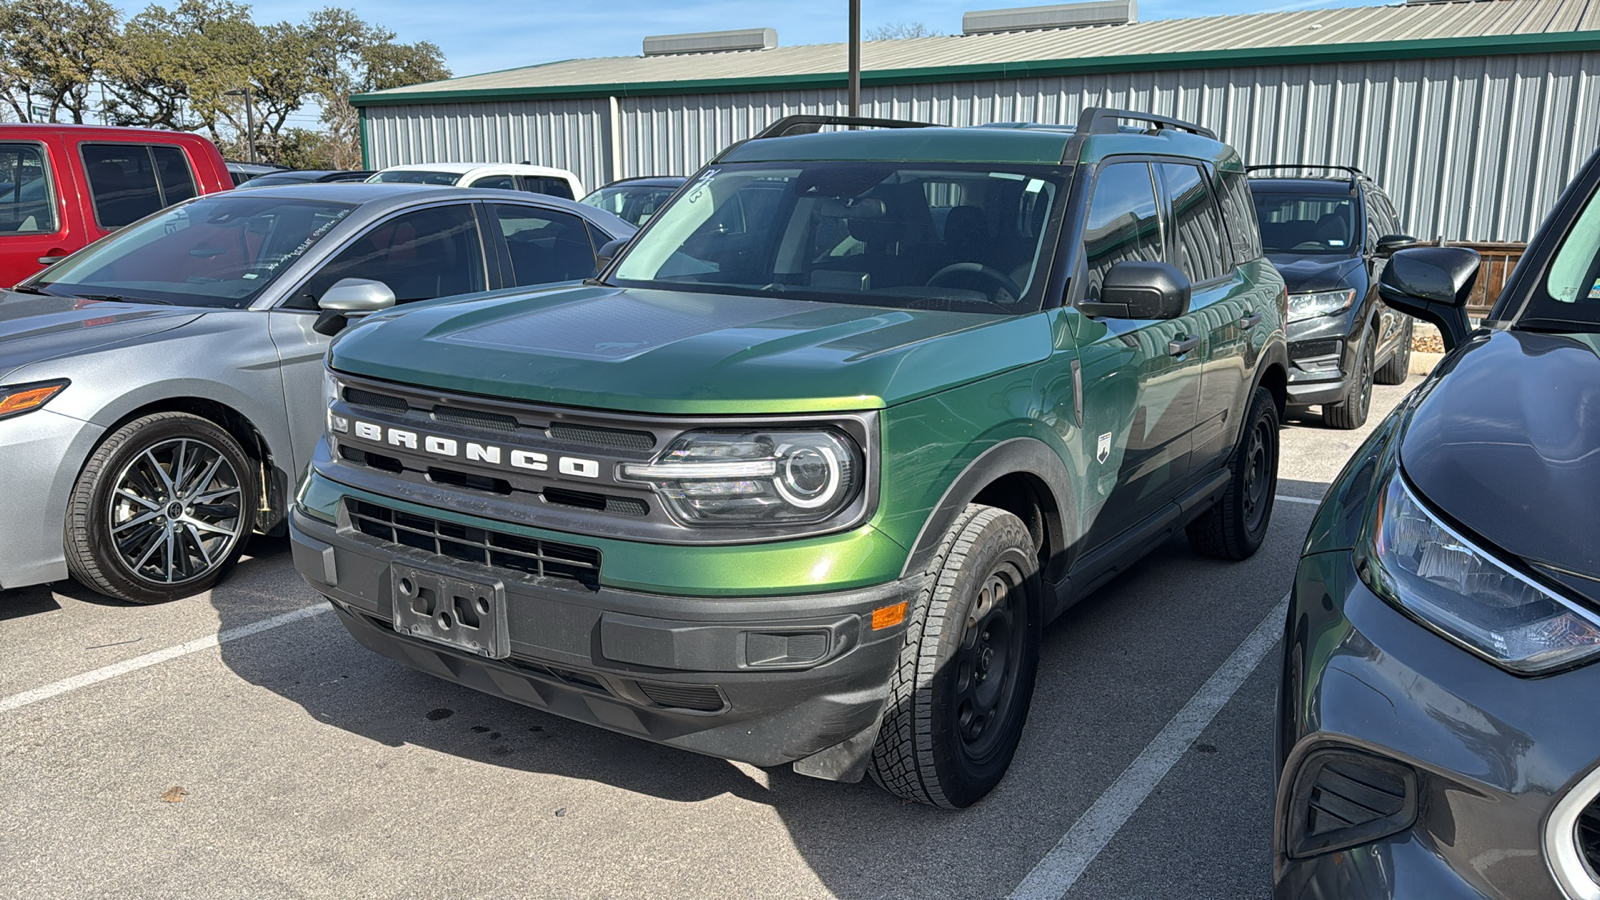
[352, 0, 1600, 106]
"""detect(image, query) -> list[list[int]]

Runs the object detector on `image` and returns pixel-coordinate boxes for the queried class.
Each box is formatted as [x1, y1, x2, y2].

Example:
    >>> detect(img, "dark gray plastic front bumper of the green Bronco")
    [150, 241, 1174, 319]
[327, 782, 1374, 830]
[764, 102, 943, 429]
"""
[290, 509, 920, 780]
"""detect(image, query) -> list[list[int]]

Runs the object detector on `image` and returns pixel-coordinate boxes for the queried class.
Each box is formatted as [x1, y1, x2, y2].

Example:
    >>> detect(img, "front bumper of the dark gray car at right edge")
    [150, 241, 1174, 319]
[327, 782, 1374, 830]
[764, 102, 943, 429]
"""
[1274, 551, 1600, 900]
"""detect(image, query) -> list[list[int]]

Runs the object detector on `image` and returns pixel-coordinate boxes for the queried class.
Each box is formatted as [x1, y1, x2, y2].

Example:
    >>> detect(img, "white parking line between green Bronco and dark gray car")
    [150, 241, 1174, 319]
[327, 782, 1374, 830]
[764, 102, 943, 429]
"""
[1011, 592, 1290, 900]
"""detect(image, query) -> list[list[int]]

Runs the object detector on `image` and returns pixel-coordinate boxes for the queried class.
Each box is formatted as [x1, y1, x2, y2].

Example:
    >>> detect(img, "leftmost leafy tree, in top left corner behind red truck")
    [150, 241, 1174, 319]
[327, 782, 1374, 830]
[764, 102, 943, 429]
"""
[0, 0, 122, 123]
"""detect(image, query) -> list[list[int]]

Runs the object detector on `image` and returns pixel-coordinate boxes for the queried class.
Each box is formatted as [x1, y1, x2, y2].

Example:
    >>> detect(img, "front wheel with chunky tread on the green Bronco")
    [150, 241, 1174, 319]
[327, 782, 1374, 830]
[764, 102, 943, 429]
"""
[867, 503, 1042, 809]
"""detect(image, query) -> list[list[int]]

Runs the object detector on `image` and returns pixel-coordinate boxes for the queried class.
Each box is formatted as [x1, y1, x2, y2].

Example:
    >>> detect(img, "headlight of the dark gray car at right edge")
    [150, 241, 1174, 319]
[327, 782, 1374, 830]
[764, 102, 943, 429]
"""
[1362, 469, 1600, 674]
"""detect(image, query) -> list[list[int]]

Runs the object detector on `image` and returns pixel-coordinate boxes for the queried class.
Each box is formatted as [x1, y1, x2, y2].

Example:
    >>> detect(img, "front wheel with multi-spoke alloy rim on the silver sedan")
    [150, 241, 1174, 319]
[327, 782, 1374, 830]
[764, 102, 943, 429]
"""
[66, 413, 258, 604]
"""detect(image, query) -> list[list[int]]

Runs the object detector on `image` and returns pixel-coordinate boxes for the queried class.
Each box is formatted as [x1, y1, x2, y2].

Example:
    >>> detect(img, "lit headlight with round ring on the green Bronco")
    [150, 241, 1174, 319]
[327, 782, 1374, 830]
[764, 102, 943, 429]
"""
[619, 429, 862, 525]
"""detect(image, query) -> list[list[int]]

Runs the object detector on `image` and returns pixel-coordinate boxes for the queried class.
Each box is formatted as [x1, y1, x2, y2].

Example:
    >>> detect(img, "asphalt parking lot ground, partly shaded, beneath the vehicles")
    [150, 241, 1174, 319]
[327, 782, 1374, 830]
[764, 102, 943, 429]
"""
[0, 376, 1418, 900]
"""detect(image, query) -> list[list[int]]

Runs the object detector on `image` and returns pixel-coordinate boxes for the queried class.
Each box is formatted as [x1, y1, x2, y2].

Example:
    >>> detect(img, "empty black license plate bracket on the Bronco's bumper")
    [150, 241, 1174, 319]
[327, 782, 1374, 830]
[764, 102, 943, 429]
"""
[389, 562, 510, 660]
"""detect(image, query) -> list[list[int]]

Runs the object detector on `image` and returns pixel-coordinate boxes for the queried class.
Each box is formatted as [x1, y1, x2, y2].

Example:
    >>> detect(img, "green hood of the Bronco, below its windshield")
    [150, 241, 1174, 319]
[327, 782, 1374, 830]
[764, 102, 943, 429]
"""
[330, 287, 1051, 415]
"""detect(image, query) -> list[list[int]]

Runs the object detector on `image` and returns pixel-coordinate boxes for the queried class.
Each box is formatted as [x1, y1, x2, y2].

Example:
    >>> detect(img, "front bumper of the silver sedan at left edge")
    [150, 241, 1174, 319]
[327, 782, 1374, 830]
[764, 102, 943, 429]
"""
[0, 408, 106, 589]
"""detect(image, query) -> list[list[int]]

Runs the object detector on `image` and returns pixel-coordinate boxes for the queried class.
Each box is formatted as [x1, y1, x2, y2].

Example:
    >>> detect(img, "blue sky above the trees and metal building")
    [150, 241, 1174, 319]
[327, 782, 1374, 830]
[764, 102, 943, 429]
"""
[232, 0, 1378, 82]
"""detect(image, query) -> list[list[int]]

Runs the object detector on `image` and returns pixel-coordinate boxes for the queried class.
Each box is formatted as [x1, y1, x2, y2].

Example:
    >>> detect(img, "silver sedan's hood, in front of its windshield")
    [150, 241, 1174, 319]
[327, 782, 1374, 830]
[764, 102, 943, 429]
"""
[0, 291, 202, 380]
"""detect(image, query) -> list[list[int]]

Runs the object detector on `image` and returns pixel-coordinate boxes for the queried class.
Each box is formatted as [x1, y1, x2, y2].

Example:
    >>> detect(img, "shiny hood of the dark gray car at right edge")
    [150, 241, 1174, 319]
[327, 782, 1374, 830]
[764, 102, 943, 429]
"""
[1400, 331, 1600, 582]
